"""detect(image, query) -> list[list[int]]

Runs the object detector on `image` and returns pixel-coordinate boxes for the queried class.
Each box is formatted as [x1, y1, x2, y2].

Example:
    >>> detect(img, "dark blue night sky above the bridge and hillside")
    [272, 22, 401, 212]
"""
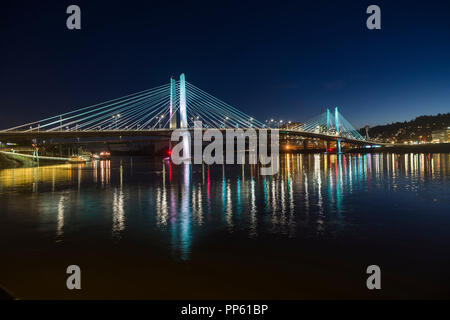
[0, 0, 450, 128]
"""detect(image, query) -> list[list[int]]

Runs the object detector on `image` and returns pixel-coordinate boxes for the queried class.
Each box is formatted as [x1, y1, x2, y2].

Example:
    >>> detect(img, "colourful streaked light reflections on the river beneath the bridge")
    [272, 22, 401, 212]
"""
[0, 154, 450, 260]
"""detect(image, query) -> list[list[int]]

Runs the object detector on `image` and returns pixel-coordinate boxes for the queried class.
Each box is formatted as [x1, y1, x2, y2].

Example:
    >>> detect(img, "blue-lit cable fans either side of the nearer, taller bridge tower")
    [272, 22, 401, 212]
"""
[3, 81, 264, 132]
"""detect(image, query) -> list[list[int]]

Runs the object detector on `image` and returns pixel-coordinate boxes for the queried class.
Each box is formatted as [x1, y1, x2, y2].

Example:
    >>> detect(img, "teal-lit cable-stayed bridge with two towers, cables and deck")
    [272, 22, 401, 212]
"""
[0, 74, 373, 149]
